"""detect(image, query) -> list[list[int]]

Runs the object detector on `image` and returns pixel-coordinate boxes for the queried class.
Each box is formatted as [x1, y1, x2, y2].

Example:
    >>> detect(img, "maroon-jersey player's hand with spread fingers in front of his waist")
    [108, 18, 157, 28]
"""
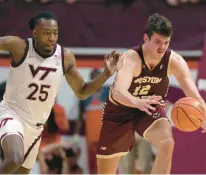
[137, 96, 162, 115]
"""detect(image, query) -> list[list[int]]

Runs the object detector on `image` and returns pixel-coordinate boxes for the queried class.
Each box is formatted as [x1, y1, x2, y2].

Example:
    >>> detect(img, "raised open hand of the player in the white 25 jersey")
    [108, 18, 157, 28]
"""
[104, 50, 120, 76]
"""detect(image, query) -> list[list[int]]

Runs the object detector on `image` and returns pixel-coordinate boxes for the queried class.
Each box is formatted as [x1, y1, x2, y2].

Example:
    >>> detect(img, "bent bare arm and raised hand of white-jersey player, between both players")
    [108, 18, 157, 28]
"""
[64, 48, 119, 99]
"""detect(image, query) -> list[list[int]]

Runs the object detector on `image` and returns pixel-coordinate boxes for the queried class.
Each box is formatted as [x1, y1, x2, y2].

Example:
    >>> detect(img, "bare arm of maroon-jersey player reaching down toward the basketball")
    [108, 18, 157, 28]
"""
[169, 52, 206, 111]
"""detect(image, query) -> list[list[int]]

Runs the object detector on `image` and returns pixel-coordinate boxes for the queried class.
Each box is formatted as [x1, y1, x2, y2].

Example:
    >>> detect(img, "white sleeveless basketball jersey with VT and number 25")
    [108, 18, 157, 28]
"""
[2, 39, 64, 125]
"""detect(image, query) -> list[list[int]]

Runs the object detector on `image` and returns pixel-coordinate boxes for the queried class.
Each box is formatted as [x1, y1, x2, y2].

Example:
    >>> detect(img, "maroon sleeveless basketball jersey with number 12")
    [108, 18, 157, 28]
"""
[128, 46, 171, 99]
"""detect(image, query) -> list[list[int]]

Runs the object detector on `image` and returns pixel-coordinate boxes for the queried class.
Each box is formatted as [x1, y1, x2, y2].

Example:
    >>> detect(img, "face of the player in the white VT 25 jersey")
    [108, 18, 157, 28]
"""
[33, 19, 58, 52]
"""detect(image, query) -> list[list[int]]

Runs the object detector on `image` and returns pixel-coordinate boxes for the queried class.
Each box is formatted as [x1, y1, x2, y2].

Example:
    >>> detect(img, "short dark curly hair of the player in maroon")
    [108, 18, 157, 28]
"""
[145, 13, 173, 38]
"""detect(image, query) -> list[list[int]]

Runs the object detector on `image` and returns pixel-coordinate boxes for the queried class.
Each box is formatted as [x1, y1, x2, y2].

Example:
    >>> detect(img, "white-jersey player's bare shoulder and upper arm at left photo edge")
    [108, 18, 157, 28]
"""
[0, 36, 26, 63]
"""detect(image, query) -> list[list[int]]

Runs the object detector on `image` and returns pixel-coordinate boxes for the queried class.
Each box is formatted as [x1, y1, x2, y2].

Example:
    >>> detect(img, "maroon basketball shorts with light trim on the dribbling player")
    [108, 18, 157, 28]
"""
[97, 99, 167, 158]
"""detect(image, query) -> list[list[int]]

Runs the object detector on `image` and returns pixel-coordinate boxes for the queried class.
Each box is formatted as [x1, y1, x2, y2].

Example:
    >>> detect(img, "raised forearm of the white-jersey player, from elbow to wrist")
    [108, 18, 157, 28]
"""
[79, 71, 110, 99]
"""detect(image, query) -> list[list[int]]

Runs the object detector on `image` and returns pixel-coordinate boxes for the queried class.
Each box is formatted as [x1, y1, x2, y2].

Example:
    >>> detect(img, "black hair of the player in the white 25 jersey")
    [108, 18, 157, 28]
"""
[29, 11, 57, 30]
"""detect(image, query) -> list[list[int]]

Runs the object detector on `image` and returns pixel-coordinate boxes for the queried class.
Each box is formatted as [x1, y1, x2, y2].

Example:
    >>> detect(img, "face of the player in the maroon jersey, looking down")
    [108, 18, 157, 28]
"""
[144, 33, 170, 57]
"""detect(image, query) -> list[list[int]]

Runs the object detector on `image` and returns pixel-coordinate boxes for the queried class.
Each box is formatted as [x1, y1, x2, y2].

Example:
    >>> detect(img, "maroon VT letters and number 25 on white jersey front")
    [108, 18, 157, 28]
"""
[27, 64, 57, 102]
